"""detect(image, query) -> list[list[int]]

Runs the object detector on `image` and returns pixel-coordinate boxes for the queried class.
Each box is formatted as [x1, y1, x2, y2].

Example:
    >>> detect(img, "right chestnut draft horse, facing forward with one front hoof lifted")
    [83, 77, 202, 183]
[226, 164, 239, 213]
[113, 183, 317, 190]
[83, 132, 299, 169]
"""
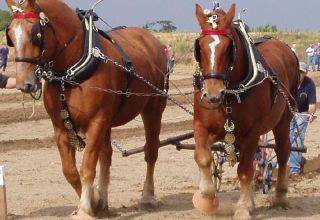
[194, 4, 299, 219]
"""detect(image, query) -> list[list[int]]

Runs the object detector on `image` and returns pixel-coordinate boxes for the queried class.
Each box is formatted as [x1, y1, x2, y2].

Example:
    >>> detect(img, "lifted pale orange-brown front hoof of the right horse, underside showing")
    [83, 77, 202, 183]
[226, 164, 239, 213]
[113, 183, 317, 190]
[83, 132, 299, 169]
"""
[192, 191, 219, 214]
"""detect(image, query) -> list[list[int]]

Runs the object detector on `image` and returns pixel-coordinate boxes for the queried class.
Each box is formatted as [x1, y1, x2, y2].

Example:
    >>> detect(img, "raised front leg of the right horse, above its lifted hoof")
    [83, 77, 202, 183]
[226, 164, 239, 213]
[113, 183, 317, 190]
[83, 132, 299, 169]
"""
[194, 123, 216, 199]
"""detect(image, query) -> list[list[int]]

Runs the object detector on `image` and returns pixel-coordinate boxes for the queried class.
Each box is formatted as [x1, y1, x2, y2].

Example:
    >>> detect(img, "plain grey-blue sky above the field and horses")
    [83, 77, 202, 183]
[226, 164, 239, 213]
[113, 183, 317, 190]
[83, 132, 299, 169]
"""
[0, 0, 320, 32]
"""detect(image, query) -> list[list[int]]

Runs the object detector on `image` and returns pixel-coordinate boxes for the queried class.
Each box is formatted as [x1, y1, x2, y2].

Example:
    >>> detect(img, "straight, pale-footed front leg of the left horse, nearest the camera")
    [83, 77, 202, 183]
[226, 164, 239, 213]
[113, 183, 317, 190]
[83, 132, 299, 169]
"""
[72, 124, 106, 219]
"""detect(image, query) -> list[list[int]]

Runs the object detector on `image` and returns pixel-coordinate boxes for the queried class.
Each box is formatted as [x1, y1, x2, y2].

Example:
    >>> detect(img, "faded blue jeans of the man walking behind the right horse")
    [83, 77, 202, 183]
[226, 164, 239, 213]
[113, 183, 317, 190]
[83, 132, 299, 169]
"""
[290, 112, 308, 174]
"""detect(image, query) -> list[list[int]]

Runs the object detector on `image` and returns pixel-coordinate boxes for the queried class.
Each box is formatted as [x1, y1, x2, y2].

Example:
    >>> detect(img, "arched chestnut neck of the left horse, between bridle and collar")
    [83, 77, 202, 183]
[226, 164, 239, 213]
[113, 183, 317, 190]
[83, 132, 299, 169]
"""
[39, 0, 84, 71]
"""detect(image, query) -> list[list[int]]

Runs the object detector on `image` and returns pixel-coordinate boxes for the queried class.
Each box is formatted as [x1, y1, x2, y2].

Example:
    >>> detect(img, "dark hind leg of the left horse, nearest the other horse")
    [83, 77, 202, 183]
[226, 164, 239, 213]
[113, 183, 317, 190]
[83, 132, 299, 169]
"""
[140, 107, 163, 208]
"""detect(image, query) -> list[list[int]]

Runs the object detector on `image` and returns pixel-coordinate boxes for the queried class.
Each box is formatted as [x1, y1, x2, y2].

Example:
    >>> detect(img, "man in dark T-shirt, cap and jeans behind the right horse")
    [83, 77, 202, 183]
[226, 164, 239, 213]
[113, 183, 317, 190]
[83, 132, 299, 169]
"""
[290, 63, 317, 176]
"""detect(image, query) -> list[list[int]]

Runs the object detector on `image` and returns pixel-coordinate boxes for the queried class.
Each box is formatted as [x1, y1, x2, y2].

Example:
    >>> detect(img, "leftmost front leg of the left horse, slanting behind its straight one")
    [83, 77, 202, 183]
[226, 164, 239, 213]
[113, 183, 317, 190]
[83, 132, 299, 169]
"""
[54, 126, 82, 198]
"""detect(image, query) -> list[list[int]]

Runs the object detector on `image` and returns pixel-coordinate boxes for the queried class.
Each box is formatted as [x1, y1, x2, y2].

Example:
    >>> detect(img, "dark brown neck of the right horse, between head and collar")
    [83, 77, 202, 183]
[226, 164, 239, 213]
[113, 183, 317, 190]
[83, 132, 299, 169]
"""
[230, 28, 248, 83]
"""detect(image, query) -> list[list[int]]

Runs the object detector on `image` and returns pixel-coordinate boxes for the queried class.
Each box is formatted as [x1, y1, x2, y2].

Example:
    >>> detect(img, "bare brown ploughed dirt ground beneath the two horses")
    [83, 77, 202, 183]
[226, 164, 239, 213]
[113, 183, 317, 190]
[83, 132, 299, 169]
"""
[0, 64, 320, 220]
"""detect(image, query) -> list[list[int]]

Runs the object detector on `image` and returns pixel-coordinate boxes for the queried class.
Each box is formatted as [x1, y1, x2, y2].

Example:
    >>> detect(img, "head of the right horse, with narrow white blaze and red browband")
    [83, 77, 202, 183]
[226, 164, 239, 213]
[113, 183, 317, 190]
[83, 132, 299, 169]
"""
[195, 4, 235, 103]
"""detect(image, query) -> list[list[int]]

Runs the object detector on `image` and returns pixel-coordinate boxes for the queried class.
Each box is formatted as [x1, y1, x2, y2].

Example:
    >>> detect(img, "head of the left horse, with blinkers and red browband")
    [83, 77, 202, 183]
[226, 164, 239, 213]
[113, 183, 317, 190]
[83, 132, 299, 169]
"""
[6, 0, 79, 93]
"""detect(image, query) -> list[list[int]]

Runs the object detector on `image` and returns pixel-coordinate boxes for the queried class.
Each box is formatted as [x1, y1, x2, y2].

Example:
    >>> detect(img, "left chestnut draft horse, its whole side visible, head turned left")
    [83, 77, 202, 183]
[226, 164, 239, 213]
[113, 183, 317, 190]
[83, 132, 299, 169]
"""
[6, 0, 166, 219]
